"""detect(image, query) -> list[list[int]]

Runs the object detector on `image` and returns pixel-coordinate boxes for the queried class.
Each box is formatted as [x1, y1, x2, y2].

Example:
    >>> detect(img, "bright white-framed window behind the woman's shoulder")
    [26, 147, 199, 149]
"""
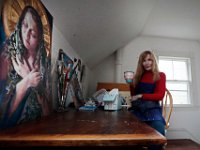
[159, 56, 192, 104]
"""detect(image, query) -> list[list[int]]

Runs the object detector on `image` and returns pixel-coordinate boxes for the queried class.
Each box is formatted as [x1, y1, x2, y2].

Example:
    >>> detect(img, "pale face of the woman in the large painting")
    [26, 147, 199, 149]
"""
[21, 12, 39, 51]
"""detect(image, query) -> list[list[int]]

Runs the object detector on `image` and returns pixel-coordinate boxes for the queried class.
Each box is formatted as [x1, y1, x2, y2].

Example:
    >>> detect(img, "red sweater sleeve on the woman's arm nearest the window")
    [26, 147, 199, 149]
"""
[142, 72, 166, 101]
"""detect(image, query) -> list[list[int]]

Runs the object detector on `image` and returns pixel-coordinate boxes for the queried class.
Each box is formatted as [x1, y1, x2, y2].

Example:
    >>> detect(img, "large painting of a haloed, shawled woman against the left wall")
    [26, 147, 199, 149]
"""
[0, 0, 52, 128]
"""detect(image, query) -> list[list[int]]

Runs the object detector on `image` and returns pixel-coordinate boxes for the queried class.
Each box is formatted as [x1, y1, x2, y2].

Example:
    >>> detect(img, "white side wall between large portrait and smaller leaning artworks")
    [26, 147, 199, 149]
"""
[51, 25, 90, 108]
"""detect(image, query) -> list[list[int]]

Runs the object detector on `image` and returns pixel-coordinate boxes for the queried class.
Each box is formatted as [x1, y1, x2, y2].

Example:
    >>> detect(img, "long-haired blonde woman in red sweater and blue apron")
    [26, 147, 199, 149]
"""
[130, 51, 166, 149]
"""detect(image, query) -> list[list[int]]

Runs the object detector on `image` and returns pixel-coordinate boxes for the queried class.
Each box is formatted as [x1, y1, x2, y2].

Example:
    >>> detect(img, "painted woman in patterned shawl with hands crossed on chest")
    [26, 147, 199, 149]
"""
[0, 6, 50, 128]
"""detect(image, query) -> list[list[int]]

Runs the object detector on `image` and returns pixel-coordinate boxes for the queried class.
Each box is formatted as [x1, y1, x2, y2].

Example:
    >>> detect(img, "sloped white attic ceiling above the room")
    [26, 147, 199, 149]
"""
[42, 0, 200, 69]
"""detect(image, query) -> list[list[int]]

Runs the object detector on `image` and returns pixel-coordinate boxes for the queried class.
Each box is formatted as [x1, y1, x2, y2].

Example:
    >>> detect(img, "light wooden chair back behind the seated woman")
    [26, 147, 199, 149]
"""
[161, 89, 173, 129]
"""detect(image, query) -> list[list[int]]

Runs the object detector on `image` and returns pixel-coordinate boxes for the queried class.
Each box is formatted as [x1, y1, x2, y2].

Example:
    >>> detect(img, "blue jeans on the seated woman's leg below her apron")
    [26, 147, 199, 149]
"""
[145, 120, 165, 150]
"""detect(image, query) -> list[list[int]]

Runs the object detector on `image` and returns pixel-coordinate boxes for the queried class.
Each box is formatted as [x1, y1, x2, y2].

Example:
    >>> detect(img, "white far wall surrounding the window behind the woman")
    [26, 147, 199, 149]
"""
[90, 37, 200, 143]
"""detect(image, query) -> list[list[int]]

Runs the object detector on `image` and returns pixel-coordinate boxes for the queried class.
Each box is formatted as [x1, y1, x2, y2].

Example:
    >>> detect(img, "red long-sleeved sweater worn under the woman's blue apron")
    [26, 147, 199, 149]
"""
[130, 71, 166, 101]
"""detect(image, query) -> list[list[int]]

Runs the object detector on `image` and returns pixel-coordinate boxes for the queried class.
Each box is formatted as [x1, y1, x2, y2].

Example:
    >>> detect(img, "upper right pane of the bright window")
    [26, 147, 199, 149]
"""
[173, 61, 188, 80]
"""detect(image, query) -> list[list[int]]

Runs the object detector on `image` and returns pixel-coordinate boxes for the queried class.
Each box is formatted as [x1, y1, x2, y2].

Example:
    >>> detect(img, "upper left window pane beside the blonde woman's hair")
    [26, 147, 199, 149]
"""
[159, 60, 174, 80]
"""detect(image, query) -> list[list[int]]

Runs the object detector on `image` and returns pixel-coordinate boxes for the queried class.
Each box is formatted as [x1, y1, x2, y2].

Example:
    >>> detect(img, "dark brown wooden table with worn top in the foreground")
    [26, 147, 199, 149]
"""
[0, 110, 167, 147]
